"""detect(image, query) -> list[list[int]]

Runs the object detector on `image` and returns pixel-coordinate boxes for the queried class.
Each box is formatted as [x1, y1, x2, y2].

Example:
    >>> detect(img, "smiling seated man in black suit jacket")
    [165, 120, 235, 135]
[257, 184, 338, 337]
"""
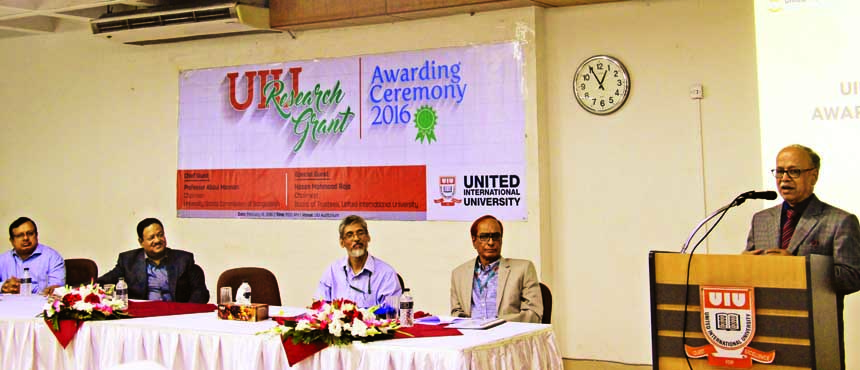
[99, 218, 209, 303]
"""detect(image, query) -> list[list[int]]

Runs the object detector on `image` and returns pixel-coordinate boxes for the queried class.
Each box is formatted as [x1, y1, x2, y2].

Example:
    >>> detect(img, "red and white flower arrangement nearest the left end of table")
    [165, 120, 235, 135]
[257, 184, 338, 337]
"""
[42, 284, 128, 330]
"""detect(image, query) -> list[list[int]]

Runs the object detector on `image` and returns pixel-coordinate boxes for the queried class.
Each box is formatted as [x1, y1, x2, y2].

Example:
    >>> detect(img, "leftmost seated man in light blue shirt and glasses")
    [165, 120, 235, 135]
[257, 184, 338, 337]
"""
[0, 217, 66, 294]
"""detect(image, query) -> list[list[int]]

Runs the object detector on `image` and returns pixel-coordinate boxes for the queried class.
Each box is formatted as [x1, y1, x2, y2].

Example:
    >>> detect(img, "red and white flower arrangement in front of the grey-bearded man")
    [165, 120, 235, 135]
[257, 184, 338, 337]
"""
[261, 299, 400, 345]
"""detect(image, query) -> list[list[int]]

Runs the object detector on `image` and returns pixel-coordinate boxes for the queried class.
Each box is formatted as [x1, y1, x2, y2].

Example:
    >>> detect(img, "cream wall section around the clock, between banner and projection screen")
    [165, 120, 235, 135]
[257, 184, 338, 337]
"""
[545, 0, 761, 363]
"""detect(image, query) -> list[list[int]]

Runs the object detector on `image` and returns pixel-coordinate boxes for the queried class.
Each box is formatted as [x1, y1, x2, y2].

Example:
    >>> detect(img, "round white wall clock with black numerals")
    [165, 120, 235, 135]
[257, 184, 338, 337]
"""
[573, 55, 630, 114]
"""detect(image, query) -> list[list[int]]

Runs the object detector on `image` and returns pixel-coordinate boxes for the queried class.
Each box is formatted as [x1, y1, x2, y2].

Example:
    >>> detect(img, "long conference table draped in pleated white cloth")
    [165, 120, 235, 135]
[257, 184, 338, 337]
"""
[0, 295, 562, 370]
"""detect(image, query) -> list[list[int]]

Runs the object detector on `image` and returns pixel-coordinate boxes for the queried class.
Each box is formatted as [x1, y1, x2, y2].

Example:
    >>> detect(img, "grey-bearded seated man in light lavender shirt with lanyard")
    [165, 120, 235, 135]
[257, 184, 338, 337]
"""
[316, 215, 401, 307]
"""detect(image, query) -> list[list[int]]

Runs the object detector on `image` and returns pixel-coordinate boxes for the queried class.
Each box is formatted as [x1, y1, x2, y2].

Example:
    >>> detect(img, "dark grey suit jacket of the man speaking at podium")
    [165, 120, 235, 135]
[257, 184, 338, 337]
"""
[746, 194, 860, 294]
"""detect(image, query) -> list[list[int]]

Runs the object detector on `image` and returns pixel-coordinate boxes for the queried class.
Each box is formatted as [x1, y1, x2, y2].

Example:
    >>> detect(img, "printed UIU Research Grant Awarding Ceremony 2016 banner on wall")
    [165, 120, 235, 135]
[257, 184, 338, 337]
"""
[176, 43, 527, 220]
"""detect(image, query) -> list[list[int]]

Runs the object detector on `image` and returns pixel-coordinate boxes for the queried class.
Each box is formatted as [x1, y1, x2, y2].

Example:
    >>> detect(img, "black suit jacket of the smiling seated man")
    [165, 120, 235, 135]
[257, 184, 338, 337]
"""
[99, 248, 209, 303]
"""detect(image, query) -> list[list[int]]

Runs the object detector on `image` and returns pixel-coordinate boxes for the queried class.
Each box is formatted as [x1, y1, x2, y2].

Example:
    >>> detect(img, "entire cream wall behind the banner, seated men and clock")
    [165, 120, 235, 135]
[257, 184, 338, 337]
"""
[5, 0, 860, 368]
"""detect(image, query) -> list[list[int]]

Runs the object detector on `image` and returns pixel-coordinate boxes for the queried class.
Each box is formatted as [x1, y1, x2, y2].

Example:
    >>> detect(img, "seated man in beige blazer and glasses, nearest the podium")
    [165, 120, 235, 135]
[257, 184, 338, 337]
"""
[451, 215, 543, 323]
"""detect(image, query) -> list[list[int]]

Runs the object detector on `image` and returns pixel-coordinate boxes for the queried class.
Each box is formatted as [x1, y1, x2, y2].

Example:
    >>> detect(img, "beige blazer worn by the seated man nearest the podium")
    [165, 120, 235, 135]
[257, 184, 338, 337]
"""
[451, 257, 543, 324]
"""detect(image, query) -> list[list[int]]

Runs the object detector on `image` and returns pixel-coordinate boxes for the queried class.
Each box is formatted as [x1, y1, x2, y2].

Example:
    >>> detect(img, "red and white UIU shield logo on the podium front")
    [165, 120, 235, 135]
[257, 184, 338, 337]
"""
[684, 286, 776, 369]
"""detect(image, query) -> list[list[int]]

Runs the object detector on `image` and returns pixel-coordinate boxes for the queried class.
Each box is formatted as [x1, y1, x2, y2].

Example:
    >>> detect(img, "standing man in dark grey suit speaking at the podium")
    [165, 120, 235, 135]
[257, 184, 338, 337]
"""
[744, 145, 860, 368]
